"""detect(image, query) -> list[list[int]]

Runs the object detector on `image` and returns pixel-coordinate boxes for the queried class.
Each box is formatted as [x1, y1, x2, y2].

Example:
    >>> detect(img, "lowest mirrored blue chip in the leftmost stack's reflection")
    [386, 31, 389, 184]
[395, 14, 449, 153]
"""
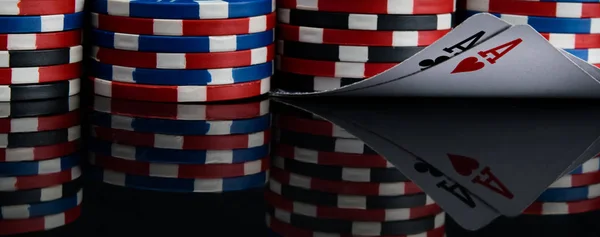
[0, 190, 83, 220]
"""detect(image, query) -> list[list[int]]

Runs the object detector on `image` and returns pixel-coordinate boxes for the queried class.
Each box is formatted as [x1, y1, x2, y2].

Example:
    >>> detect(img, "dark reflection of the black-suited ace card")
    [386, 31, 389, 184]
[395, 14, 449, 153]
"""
[276, 101, 500, 230]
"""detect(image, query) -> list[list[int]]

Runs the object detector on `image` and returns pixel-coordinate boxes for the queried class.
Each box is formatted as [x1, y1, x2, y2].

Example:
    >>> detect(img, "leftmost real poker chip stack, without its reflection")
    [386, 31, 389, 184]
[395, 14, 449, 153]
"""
[0, 0, 84, 101]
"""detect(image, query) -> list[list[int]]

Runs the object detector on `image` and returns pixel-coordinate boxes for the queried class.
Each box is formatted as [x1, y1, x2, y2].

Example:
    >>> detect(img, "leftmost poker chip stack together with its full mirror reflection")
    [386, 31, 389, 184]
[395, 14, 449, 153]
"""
[0, 0, 84, 235]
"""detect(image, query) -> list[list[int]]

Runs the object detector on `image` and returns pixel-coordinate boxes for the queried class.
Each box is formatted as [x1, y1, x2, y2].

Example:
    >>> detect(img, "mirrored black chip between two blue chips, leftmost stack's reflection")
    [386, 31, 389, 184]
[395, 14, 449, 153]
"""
[0, 178, 83, 206]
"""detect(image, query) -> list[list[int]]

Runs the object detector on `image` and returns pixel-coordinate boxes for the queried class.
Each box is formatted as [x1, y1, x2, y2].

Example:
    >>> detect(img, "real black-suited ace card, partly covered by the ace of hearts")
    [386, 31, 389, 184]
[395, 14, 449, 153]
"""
[273, 13, 511, 96]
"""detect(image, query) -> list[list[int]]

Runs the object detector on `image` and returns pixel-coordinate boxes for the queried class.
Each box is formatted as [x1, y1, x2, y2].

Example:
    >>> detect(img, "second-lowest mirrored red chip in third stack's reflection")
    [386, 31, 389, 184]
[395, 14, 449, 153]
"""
[265, 191, 442, 222]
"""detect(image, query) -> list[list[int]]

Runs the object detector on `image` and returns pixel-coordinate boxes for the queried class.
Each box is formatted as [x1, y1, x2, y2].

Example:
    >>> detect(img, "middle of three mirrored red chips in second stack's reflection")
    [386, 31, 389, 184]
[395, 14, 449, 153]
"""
[92, 126, 271, 150]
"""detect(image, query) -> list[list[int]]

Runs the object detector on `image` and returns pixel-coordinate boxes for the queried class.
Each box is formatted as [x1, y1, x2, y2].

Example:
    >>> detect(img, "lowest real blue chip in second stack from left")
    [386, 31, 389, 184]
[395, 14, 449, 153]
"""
[90, 60, 273, 86]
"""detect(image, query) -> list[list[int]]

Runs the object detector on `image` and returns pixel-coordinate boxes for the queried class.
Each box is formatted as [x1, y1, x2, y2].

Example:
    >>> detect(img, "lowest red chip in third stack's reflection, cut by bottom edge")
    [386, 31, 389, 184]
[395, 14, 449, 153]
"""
[266, 214, 446, 237]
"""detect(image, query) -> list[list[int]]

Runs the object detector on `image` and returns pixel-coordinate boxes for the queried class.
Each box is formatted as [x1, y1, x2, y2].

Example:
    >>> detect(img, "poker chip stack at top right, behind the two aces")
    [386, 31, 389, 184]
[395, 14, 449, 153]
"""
[460, 0, 600, 66]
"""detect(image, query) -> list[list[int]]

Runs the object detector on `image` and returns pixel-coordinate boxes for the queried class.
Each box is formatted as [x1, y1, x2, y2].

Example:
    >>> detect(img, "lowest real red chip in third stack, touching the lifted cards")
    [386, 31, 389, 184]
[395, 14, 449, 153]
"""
[276, 55, 398, 78]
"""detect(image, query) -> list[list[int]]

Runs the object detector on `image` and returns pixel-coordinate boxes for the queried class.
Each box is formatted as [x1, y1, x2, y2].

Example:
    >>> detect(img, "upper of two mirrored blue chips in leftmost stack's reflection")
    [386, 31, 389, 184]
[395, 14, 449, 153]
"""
[0, 154, 80, 177]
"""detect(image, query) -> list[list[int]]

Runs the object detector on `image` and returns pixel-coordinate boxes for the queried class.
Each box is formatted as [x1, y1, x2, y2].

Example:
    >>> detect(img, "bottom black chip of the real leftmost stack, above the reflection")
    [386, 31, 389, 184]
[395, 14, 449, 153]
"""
[0, 79, 81, 101]
